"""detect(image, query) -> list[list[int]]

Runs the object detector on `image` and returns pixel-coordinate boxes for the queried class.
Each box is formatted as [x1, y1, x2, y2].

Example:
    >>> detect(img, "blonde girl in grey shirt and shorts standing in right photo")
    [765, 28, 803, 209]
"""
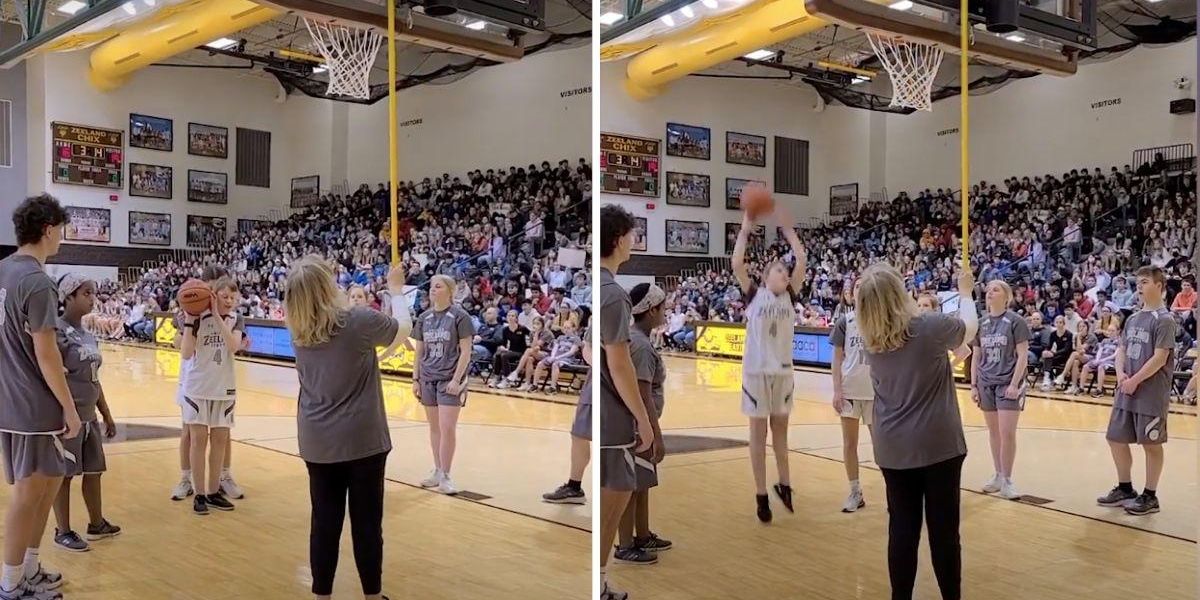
[971, 280, 1032, 500]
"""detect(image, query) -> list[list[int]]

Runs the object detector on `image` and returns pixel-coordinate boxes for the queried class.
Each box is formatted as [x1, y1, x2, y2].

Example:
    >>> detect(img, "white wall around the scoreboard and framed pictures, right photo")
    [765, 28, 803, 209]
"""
[600, 61, 882, 256]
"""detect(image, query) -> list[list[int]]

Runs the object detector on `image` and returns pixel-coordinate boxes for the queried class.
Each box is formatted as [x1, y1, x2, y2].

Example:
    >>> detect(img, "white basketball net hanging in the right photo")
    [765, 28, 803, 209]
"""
[866, 32, 946, 110]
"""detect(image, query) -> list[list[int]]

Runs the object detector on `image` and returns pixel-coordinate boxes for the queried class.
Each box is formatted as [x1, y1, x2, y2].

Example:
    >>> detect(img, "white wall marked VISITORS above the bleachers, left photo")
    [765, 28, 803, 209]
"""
[347, 46, 592, 183]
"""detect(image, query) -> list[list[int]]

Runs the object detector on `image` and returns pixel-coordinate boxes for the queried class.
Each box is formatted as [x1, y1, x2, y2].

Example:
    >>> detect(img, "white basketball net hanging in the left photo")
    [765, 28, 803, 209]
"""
[304, 18, 383, 100]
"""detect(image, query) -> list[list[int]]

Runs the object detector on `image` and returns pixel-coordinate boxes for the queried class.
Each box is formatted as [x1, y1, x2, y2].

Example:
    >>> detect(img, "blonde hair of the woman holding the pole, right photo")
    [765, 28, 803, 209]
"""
[854, 263, 917, 354]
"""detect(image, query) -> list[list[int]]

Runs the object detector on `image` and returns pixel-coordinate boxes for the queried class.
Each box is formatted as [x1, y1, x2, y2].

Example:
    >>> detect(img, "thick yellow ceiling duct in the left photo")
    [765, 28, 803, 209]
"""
[88, 0, 283, 91]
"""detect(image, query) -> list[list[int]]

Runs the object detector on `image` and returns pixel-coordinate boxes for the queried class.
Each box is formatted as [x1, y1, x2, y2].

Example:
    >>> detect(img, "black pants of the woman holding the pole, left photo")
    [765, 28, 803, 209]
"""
[306, 452, 388, 595]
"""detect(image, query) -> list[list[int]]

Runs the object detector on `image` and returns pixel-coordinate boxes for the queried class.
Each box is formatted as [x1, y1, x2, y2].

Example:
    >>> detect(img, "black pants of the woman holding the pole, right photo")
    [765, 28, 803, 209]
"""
[881, 455, 966, 600]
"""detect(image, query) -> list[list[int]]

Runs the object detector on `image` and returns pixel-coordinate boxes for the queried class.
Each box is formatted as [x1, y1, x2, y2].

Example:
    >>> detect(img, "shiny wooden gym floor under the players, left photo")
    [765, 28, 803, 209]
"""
[0, 344, 592, 600]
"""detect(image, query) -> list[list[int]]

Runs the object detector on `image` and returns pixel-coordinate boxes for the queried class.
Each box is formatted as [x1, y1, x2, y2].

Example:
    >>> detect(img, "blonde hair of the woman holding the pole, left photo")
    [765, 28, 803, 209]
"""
[283, 256, 347, 347]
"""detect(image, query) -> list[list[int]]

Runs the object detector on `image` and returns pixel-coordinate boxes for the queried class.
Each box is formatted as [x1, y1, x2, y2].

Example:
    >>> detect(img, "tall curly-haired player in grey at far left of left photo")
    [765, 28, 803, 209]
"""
[0, 194, 80, 600]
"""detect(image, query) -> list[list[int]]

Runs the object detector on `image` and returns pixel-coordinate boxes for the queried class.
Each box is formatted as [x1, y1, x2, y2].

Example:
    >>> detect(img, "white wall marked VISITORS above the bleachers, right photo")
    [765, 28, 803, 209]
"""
[886, 37, 1196, 194]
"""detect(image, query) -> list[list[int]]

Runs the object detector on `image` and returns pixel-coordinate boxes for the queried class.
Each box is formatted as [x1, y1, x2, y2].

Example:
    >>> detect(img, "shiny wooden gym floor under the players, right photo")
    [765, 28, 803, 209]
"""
[610, 356, 1200, 600]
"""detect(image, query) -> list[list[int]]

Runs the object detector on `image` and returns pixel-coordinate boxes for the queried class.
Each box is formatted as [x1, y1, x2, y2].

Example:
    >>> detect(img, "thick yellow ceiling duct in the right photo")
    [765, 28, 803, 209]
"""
[625, 0, 827, 100]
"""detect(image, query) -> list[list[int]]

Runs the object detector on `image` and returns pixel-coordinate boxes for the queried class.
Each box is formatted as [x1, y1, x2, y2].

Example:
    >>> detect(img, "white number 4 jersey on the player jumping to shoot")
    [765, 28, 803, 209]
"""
[742, 288, 796, 374]
